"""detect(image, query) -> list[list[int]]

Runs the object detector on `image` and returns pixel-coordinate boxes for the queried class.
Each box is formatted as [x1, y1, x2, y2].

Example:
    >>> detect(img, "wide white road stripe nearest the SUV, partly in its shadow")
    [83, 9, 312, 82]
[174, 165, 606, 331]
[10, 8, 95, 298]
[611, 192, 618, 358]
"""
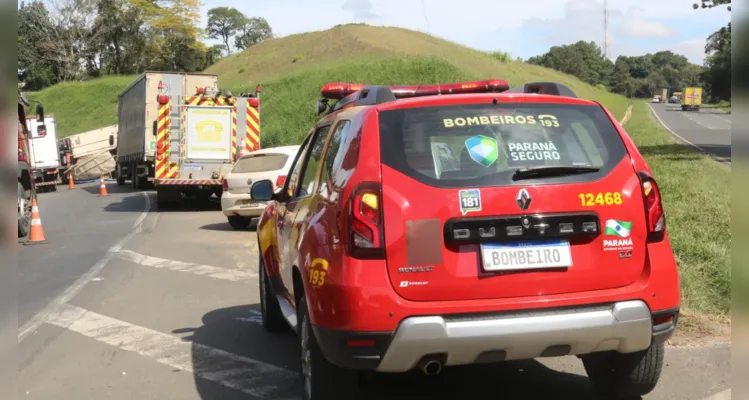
[47, 304, 298, 400]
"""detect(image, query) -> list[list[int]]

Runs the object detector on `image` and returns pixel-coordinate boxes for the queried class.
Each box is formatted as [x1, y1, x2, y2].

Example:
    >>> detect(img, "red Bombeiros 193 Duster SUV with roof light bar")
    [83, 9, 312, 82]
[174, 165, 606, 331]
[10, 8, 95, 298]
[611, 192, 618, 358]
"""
[251, 80, 680, 400]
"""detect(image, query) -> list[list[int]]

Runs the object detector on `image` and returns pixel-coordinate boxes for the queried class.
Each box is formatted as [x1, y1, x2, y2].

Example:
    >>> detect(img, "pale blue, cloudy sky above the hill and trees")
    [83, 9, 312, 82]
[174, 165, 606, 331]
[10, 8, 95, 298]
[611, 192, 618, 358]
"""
[201, 0, 731, 65]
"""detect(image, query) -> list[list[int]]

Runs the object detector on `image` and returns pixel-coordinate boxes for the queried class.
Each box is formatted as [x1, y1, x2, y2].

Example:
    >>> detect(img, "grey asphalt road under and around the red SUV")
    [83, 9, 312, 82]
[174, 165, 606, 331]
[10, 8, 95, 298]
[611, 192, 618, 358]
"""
[18, 184, 730, 400]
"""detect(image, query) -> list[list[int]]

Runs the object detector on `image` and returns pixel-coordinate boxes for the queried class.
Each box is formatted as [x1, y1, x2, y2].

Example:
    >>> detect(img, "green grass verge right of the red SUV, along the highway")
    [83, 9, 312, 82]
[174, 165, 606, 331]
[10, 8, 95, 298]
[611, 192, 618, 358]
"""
[627, 102, 731, 314]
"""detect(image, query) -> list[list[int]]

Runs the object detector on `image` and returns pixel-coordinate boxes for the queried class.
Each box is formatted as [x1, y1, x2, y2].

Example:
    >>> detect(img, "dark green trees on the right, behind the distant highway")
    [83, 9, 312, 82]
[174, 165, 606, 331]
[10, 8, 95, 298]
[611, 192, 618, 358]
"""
[525, 0, 731, 102]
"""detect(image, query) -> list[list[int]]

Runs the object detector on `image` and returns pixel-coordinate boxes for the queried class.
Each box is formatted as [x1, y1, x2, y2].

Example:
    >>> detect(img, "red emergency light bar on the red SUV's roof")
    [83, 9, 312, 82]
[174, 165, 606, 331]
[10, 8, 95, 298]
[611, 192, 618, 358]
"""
[320, 79, 510, 100]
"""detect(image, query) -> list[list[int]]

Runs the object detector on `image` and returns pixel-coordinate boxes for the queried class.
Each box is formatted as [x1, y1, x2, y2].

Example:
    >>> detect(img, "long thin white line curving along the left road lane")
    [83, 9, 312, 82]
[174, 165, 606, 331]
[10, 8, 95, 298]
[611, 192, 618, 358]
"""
[18, 192, 151, 343]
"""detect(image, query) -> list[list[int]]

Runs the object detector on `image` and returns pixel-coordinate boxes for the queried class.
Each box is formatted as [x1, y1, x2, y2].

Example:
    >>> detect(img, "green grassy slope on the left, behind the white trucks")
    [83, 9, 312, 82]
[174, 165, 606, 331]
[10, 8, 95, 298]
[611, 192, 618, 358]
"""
[26, 76, 136, 137]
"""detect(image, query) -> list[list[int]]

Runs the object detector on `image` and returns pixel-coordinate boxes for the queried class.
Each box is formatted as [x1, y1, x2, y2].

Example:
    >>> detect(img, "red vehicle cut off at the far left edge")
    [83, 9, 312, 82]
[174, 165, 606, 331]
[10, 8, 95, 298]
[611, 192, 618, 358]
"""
[17, 70, 47, 238]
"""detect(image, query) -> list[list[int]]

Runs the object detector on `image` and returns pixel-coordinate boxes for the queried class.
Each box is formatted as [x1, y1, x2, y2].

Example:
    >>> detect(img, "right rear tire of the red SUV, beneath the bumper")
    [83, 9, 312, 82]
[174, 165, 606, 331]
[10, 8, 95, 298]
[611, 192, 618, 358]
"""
[582, 343, 664, 398]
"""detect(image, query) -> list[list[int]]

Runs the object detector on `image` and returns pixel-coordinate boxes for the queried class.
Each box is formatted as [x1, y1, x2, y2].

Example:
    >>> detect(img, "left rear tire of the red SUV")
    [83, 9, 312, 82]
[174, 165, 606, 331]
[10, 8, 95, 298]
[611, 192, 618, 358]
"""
[297, 293, 360, 400]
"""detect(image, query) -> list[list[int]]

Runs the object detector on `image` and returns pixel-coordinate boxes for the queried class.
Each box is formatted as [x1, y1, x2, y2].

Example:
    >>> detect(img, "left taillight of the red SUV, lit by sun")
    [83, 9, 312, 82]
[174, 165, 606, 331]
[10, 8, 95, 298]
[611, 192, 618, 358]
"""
[349, 182, 385, 259]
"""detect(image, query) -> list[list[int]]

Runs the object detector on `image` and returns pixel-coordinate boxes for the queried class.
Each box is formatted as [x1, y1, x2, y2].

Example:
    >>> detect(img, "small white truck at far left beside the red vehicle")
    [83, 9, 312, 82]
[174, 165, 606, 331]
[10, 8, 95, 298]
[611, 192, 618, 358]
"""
[26, 115, 60, 192]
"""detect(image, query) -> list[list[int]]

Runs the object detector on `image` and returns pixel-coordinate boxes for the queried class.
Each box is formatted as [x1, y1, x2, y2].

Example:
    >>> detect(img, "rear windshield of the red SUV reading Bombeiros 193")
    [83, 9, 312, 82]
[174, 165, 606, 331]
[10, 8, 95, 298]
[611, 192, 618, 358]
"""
[379, 103, 626, 187]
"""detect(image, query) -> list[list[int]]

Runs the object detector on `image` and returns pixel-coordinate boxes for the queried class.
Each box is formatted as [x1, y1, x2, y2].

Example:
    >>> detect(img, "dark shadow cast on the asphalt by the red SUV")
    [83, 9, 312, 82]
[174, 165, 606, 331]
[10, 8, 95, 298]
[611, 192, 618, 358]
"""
[177, 304, 640, 400]
